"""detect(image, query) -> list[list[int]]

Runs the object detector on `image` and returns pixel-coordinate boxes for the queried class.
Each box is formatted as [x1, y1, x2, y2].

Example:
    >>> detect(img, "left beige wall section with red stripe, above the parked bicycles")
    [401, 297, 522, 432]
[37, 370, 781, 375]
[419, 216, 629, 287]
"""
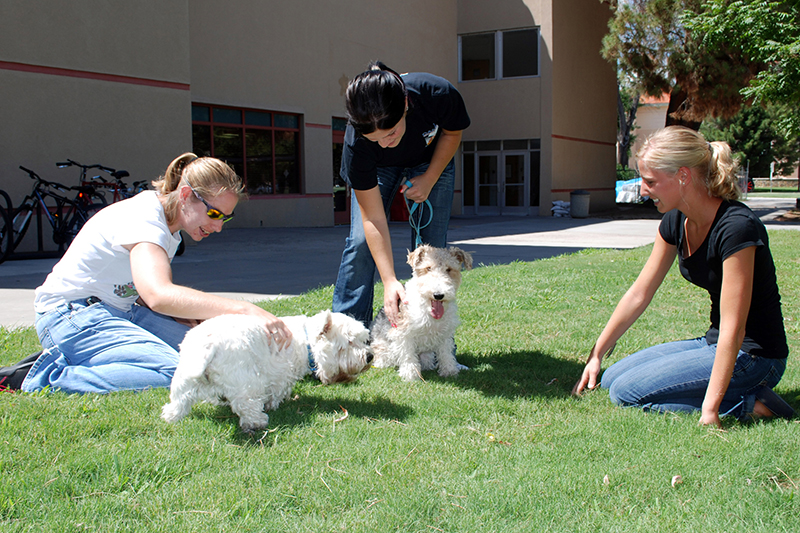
[0, 0, 191, 251]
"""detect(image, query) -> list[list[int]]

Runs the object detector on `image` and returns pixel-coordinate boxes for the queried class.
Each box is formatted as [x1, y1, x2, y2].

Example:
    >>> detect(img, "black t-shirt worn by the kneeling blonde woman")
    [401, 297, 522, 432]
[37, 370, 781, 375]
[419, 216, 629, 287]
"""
[659, 201, 789, 359]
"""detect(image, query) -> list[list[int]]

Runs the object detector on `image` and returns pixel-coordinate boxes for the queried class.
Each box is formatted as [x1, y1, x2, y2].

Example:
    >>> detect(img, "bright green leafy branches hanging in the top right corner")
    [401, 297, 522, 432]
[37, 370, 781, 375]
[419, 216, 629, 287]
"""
[684, 0, 800, 134]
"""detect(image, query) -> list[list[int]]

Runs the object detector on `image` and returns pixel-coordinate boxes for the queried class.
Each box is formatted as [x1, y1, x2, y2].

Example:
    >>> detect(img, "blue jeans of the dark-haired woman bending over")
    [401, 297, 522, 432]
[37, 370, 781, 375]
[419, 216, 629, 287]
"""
[333, 160, 455, 327]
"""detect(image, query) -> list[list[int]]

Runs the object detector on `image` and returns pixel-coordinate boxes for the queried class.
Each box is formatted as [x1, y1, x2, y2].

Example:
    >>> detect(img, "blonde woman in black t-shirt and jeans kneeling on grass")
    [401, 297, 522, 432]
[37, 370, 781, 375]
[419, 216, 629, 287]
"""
[573, 126, 794, 426]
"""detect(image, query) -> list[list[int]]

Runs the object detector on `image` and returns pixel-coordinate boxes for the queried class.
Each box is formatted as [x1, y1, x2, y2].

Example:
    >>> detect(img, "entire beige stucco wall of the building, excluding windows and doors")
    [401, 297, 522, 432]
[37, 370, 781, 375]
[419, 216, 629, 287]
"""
[0, 0, 615, 235]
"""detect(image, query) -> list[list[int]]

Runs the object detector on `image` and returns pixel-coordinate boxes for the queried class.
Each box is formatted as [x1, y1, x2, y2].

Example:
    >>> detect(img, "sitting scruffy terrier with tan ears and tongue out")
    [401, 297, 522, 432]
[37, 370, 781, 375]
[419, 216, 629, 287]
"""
[370, 244, 472, 381]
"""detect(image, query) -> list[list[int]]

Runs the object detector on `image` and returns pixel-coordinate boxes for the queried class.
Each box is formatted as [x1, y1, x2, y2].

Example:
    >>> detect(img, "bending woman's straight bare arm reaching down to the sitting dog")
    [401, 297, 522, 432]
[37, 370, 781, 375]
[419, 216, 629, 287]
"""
[355, 186, 406, 324]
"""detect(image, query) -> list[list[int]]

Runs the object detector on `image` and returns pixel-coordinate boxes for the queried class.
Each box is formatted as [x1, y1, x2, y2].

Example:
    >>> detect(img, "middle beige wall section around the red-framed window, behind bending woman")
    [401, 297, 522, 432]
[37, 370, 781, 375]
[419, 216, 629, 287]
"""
[190, 0, 460, 226]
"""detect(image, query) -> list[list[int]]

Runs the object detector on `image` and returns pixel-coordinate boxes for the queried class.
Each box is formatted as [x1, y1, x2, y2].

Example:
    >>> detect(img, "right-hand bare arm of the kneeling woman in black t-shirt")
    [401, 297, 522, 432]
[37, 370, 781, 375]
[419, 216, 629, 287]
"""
[700, 246, 756, 427]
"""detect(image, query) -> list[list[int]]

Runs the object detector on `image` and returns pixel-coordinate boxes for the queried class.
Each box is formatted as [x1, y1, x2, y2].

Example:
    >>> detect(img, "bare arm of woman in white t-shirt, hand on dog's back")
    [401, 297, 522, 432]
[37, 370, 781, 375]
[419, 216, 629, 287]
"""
[130, 242, 292, 344]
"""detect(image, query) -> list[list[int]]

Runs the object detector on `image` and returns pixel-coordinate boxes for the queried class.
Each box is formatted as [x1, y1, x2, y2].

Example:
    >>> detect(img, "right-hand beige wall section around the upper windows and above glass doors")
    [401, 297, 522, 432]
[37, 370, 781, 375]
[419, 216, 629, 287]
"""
[458, 0, 616, 216]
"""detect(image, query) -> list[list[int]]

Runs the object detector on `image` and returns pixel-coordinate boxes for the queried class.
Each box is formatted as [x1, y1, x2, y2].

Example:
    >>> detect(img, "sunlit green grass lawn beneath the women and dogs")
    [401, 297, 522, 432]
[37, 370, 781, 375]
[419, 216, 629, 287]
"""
[0, 230, 800, 533]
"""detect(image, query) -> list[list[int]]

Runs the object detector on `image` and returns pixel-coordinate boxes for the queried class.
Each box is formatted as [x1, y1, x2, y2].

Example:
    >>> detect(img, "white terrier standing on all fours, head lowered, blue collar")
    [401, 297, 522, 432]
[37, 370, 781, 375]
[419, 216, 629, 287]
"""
[161, 311, 372, 432]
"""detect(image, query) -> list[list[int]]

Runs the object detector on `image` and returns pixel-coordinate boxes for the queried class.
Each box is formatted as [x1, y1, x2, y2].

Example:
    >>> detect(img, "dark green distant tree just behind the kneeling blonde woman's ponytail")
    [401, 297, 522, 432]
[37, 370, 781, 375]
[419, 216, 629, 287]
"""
[700, 105, 800, 177]
